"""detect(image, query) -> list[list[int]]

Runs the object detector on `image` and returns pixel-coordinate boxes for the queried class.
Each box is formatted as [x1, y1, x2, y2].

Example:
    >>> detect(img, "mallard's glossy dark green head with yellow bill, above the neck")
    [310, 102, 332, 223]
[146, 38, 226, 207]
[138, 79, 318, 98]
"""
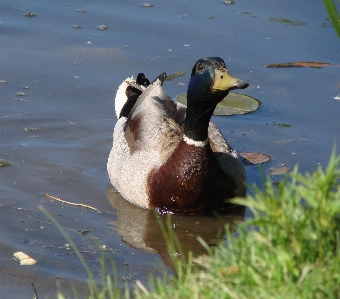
[187, 57, 248, 106]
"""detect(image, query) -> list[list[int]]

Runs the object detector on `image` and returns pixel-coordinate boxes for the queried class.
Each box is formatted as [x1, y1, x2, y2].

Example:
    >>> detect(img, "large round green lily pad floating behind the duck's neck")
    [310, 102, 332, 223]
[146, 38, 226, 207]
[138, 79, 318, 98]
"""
[176, 92, 261, 116]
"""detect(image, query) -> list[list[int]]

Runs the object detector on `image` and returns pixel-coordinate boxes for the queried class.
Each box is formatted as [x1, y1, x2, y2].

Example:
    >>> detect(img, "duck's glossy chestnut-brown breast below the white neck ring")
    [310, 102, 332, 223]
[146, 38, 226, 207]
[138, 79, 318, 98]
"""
[147, 139, 235, 212]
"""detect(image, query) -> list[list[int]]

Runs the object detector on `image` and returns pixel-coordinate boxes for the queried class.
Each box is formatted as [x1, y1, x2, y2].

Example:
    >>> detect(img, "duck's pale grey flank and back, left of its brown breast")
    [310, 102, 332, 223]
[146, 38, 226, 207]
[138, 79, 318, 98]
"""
[107, 80, 186, 208]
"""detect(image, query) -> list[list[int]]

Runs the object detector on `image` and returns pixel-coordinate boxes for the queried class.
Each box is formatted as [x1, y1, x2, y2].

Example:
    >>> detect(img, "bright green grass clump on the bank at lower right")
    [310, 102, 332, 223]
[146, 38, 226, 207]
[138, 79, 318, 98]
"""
[136, 154, 340, 299]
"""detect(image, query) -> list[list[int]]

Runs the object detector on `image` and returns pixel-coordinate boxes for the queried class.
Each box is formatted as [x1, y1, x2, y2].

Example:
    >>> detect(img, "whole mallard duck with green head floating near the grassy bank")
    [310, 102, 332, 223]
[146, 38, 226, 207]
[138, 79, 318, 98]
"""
[107, 57, 248, 213]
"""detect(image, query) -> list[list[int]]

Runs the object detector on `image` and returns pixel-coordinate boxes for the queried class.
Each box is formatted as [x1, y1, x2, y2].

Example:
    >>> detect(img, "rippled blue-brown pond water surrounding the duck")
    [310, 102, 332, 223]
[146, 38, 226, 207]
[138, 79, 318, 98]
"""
[0, 0, 340, 299]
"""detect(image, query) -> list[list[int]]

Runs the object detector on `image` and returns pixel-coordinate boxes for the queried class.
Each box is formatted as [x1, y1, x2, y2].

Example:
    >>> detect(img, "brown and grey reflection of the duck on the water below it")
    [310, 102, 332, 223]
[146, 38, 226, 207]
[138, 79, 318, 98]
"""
[106, 186, 245, 270]
